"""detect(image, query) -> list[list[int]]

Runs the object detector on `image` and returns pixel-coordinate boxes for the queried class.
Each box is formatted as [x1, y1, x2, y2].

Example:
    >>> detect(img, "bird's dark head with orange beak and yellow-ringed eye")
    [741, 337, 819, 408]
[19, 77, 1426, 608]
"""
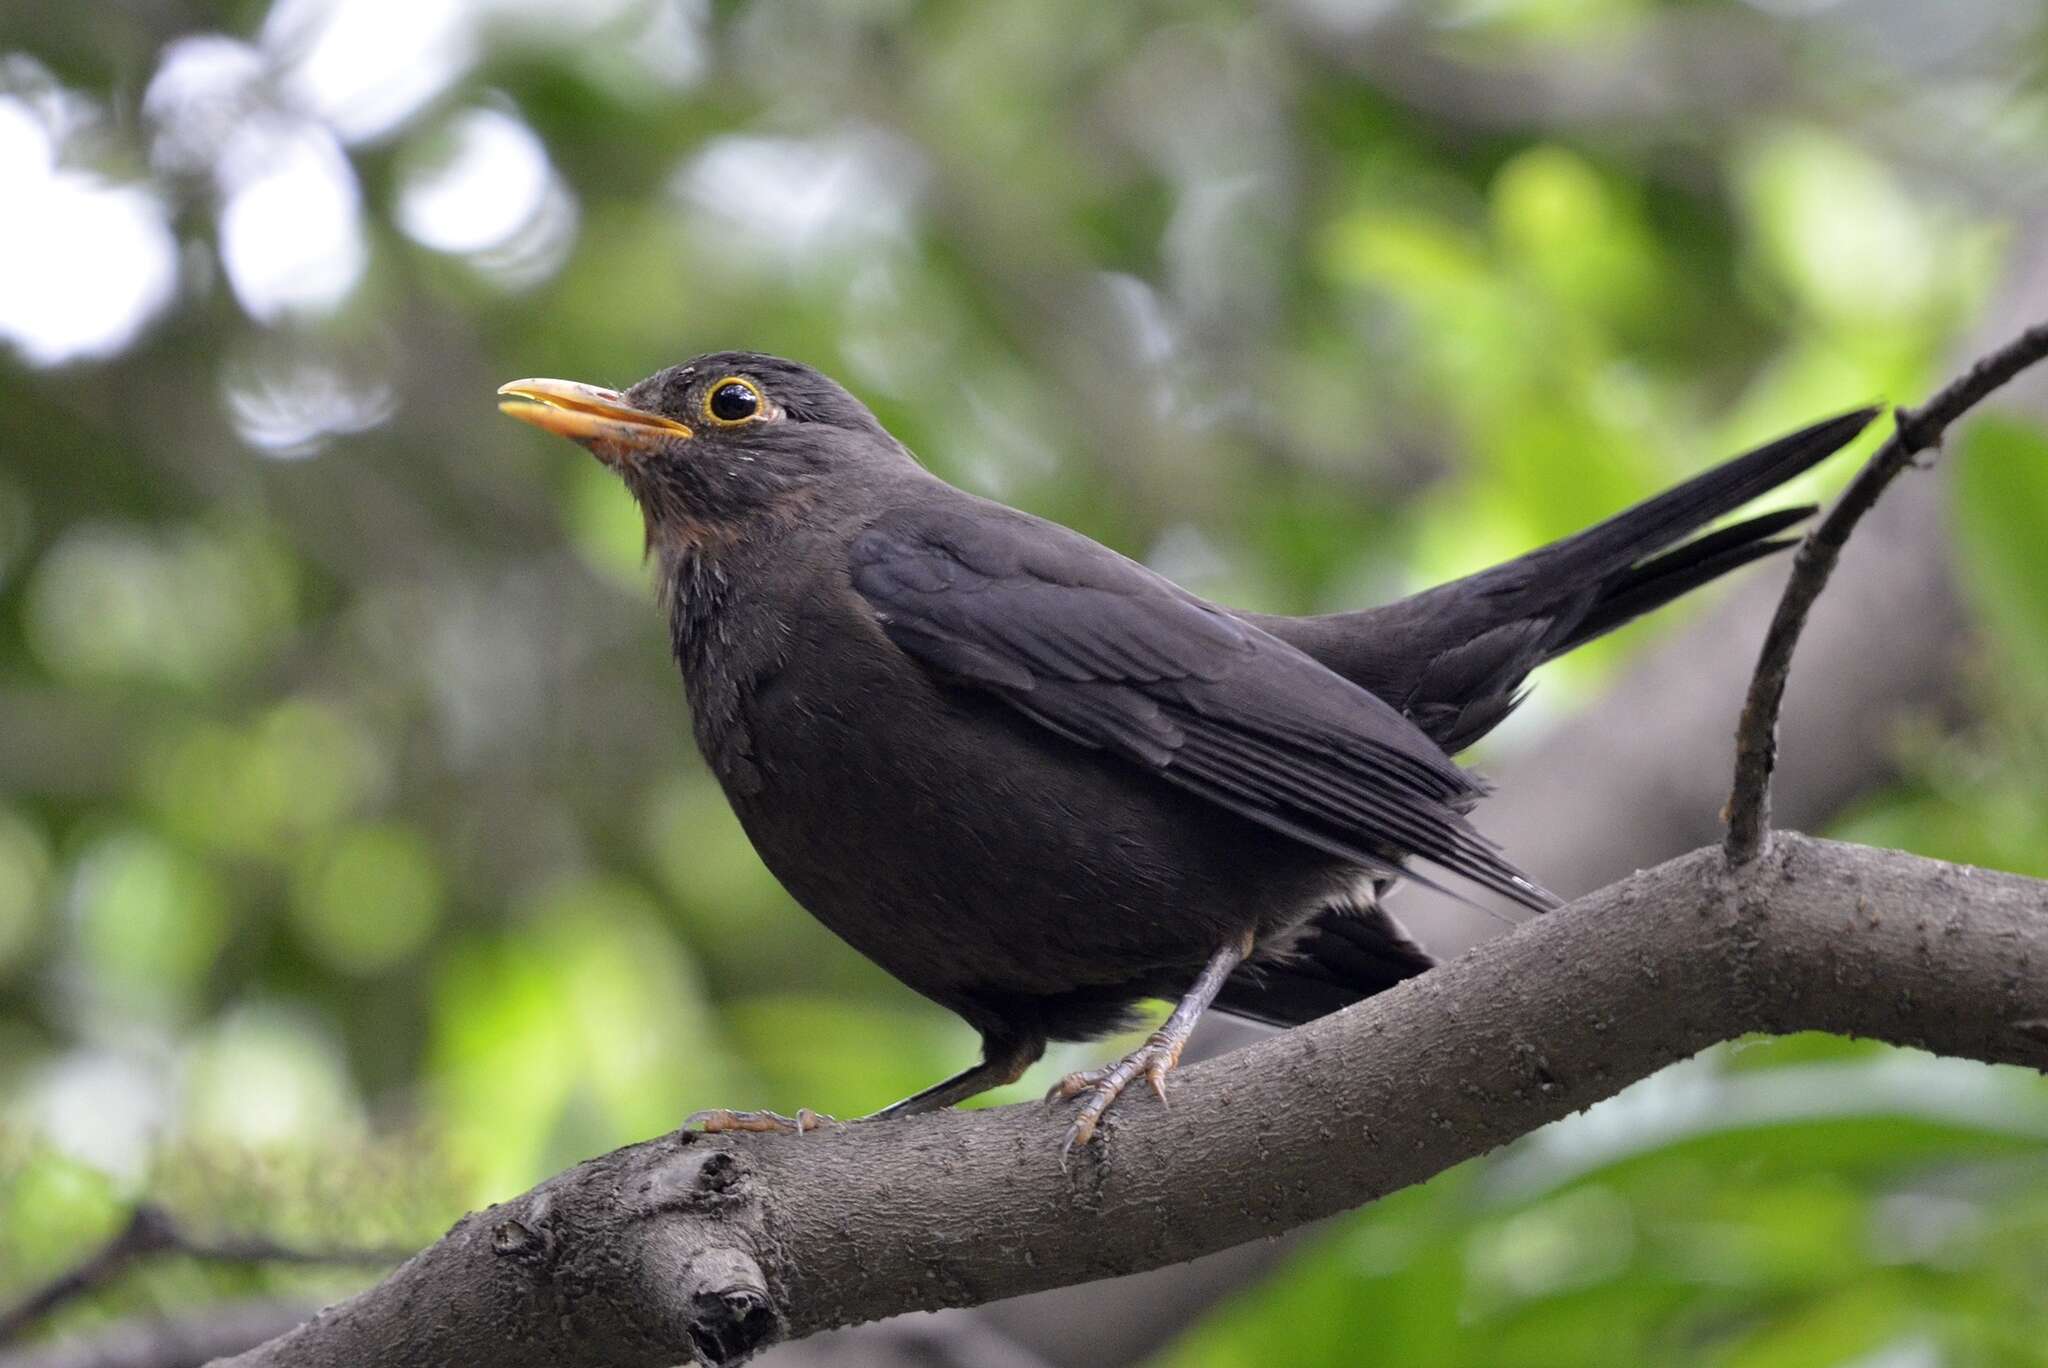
[498, 352, 909, 545]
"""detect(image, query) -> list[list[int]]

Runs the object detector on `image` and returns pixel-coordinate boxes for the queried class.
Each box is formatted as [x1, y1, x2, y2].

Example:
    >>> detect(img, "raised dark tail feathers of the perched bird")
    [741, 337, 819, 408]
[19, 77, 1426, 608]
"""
[1255, 408, 1880, 752]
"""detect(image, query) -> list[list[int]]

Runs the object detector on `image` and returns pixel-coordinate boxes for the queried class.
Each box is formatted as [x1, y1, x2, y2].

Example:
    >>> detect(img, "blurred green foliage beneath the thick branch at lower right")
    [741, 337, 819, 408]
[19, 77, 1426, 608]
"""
[1163, 1036, 2048, 1368]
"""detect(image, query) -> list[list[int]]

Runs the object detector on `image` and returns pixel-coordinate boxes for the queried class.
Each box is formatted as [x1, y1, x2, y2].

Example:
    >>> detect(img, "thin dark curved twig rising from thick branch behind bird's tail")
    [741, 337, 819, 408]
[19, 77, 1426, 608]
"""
[1722, 324, 2048, 864]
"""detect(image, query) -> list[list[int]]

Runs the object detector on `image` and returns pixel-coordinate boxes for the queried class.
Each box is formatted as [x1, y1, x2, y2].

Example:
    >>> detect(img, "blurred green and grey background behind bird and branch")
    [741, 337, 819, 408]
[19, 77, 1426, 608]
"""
[0, 0, 2048, 1368]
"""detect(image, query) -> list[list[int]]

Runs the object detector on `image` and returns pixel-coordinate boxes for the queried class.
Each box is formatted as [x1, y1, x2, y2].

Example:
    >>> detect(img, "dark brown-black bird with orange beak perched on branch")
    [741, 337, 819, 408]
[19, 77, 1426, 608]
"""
[500, 350, 1878, 1163]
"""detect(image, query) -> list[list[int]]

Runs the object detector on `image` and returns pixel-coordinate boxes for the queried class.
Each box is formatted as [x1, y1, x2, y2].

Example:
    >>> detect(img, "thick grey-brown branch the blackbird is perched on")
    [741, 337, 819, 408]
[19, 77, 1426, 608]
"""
[220, 836, 2048, 1368]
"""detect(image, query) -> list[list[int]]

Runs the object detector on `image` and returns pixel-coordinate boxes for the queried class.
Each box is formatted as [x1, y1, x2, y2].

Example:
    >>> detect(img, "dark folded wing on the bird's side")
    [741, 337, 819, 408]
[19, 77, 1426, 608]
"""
[850, 502, 1556, 909]
